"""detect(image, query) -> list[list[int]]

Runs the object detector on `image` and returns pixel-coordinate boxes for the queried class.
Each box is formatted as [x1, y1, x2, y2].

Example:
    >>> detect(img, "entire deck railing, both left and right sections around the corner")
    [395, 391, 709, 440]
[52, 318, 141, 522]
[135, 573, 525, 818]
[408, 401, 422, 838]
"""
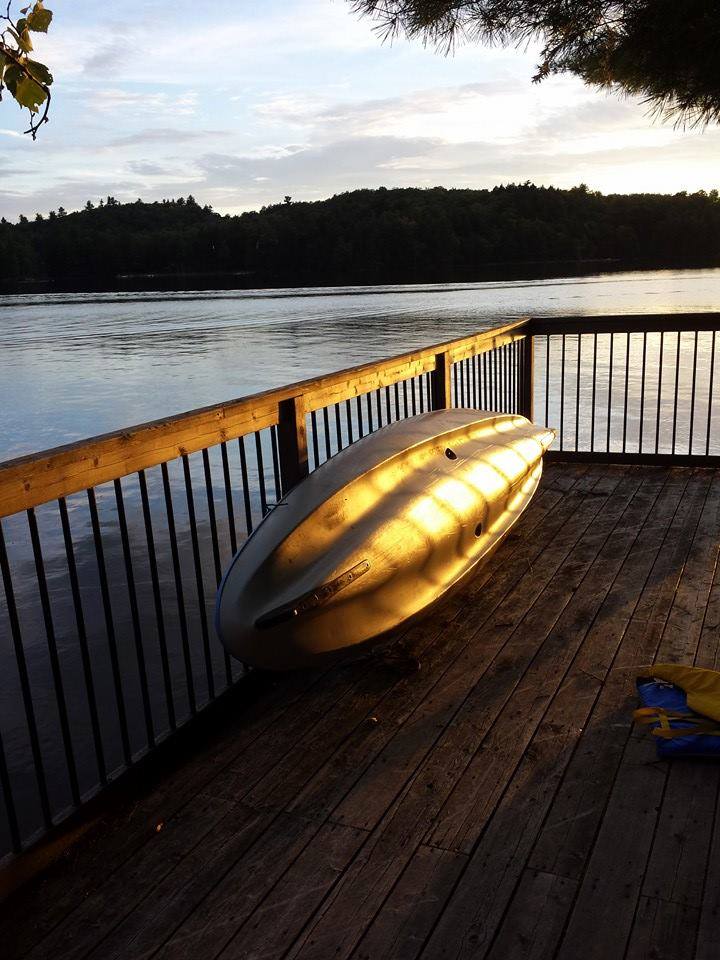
[0, 314, 720, 859]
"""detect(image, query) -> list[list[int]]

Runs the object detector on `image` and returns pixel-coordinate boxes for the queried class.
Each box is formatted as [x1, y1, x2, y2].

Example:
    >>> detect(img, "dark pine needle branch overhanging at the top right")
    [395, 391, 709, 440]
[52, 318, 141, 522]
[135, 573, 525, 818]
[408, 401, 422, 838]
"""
[350, 0, 720, 124]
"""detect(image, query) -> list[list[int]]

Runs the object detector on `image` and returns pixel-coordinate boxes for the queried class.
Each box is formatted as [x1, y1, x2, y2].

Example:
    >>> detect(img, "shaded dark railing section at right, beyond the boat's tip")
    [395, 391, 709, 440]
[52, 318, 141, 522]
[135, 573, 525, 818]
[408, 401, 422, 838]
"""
[531, 313, 720, 464]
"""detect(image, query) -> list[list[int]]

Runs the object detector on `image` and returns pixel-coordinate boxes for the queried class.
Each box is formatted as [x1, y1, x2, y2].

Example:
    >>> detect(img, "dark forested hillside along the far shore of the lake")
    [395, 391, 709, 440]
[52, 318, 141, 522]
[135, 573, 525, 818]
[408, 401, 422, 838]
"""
[0, 184, 720, 286]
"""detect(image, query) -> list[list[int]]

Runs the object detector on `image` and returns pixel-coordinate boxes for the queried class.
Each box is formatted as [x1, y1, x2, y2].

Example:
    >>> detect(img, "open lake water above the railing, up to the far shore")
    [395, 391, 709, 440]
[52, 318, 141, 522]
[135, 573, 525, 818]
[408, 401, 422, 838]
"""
[0, 269, 720, 460]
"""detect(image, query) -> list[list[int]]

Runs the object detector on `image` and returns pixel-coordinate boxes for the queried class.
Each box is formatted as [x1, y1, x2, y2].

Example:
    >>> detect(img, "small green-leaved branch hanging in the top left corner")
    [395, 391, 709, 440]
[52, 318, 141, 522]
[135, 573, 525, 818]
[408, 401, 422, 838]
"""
[0, 0, 53, 140]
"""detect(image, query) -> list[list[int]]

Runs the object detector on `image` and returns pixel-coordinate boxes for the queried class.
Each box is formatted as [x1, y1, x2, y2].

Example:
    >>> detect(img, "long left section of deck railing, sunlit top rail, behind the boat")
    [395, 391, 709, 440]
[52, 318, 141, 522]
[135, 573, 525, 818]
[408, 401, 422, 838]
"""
[0, 321, 529, 858]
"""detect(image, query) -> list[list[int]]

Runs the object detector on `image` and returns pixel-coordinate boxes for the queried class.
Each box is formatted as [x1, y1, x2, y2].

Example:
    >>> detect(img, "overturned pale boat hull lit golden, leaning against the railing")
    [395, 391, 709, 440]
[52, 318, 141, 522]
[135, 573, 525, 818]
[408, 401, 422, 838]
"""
[216, 409, 555, 670]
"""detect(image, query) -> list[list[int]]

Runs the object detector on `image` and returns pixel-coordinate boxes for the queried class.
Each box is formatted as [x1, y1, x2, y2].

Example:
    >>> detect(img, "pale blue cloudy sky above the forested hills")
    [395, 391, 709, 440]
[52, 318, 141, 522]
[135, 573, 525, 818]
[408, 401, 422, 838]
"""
[0, 0, 720, 219]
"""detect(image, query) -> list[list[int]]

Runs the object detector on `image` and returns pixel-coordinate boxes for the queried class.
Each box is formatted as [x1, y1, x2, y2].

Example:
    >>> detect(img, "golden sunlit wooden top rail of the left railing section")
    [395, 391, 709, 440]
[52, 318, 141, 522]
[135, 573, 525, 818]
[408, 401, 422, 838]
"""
[0, 319, 528, 518]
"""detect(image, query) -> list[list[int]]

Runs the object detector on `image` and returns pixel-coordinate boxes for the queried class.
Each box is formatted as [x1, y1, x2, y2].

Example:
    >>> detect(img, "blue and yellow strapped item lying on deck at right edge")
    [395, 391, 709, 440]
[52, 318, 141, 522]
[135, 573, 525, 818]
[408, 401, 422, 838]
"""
[634, 663, 720, 759]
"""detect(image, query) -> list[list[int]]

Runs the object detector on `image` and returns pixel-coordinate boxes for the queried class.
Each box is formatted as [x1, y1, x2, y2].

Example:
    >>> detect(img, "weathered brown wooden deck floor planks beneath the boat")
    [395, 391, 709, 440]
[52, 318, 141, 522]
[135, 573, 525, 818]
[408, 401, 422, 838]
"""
[0, 464, 720, 960]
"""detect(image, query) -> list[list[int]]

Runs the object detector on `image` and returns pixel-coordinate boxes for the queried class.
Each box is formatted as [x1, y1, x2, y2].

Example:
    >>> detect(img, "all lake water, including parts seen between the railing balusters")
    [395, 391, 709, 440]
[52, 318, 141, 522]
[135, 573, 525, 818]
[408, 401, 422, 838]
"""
[0, 269, 720, 858]
